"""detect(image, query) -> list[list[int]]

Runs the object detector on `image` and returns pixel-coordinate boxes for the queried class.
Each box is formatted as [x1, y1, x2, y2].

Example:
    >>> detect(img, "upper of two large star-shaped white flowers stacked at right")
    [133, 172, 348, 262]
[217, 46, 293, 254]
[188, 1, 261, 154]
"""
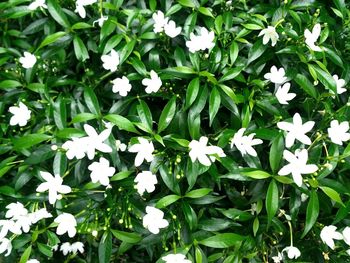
[277, 113, 315, 148]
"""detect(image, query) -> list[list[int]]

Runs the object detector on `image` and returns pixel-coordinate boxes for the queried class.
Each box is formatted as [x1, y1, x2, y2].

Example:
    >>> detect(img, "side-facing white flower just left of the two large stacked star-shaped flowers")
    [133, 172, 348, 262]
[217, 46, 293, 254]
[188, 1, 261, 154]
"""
[231, 128, 263, 157]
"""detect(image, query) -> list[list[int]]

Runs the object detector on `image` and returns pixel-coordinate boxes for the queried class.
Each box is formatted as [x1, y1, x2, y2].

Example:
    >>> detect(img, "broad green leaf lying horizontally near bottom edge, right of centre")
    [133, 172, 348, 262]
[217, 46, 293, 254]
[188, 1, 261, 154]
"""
[198, 233, 245, 248]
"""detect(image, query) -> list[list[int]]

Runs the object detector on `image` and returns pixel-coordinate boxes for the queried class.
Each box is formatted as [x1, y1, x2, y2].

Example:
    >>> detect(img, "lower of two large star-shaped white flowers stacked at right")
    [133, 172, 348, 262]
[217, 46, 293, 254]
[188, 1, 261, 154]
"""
[278, 149, 318, 187]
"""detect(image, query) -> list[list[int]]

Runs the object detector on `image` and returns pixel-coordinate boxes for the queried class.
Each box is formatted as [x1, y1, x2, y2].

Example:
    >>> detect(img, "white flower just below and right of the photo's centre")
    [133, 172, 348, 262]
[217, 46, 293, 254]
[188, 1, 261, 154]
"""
[188, 136, 226, 166]
